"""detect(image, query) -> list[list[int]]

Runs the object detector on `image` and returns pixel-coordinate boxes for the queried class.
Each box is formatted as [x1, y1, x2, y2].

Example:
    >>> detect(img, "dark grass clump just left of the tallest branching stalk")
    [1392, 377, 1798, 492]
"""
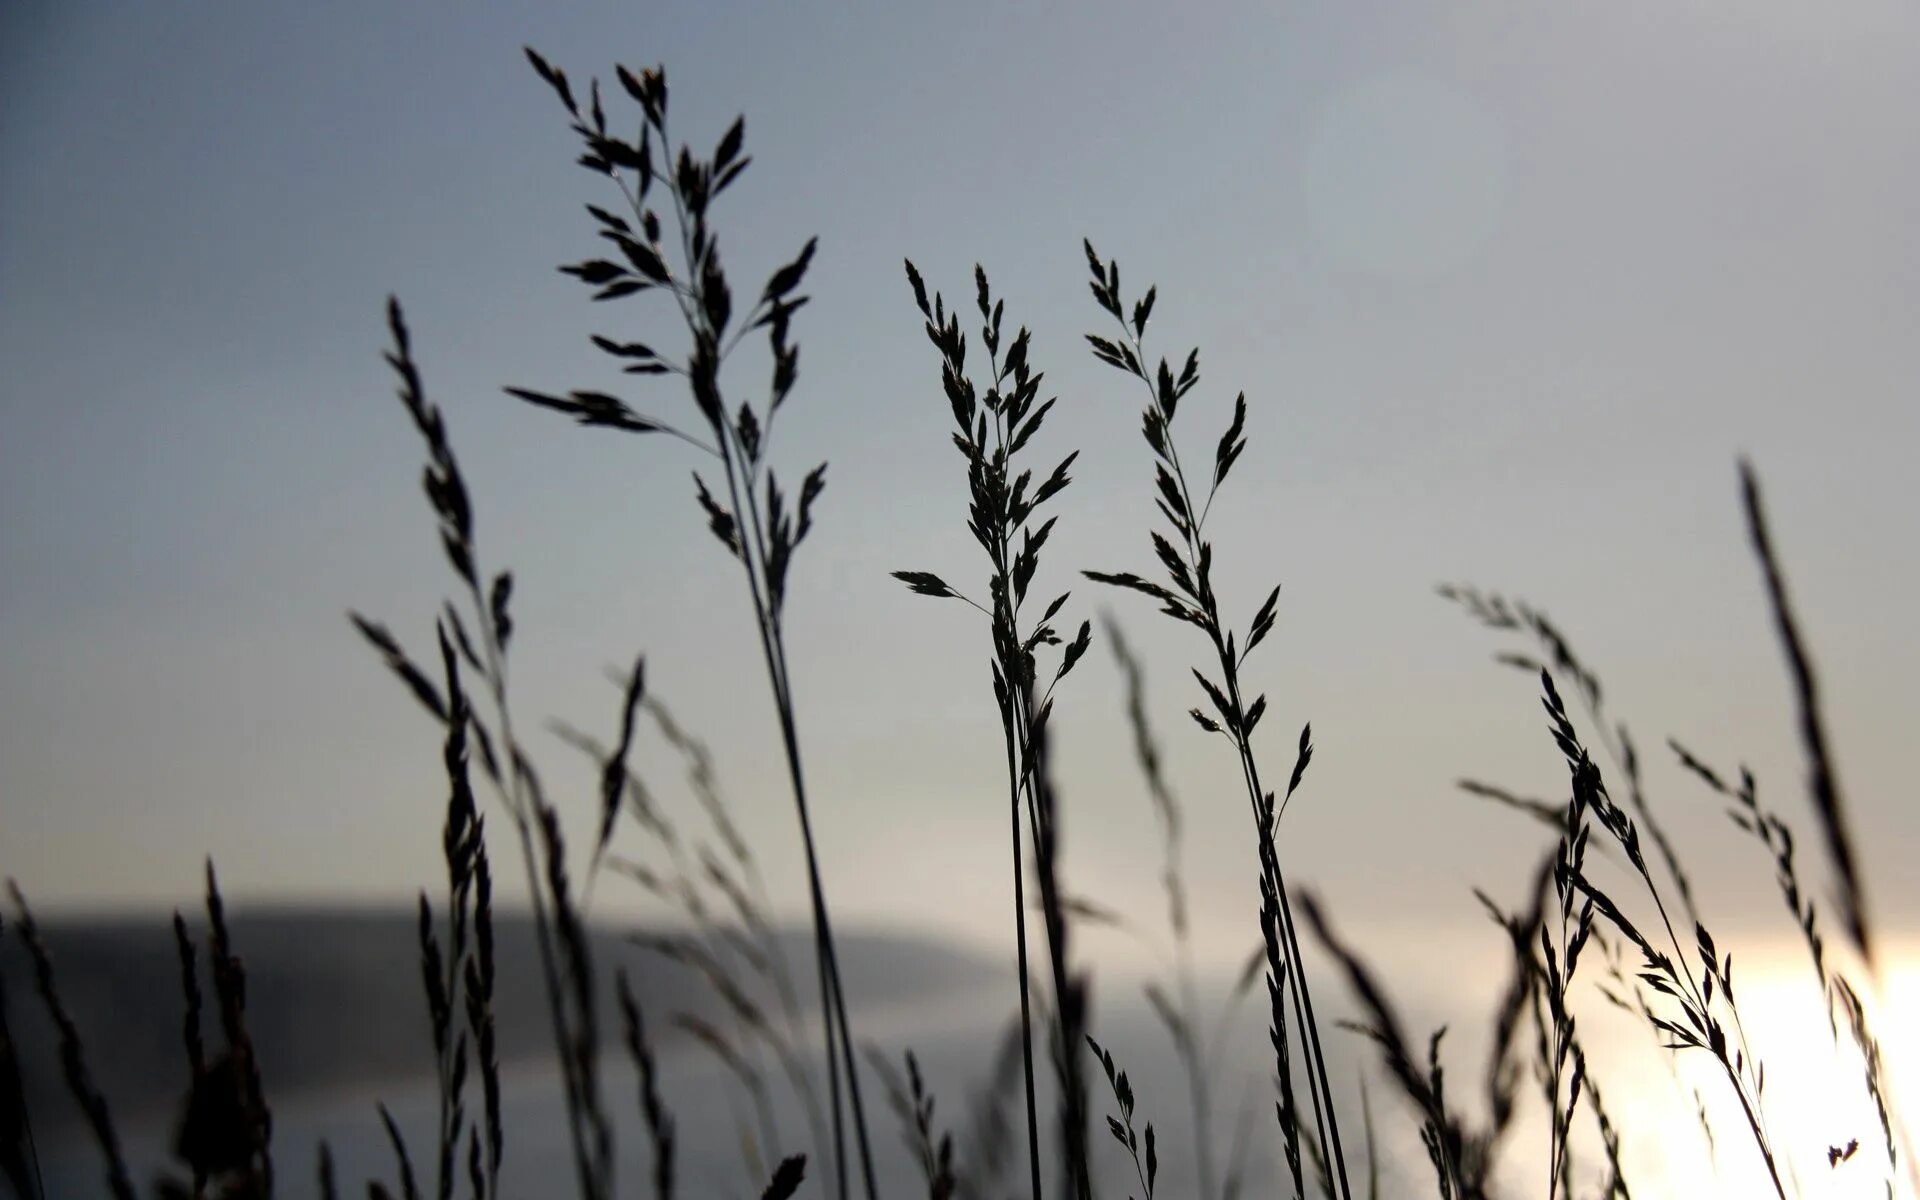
[362, 282, 804, 1200]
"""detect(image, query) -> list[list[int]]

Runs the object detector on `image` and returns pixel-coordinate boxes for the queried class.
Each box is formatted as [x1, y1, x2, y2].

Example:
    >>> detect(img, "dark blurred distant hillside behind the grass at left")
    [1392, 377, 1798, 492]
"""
[0, 908, 1006, 1125]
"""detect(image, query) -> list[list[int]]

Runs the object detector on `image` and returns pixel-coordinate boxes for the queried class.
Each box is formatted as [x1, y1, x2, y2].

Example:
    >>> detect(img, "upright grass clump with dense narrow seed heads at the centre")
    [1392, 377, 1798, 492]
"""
[893, 261, 1092, 1200]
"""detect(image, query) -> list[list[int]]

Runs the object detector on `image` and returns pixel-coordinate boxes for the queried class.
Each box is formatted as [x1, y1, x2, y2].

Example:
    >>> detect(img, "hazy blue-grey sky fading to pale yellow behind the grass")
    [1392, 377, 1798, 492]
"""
[0, 0, 1920, 990]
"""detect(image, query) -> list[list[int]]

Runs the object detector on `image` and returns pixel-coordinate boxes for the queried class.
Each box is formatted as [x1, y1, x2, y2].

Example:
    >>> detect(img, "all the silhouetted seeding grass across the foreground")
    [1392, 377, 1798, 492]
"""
[0, 52, 1920, 1200]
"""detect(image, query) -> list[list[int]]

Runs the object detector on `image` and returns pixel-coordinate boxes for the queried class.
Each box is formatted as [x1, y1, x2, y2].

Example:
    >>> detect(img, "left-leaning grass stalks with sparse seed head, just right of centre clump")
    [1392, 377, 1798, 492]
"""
[1085, 242, 1352, 1200]
